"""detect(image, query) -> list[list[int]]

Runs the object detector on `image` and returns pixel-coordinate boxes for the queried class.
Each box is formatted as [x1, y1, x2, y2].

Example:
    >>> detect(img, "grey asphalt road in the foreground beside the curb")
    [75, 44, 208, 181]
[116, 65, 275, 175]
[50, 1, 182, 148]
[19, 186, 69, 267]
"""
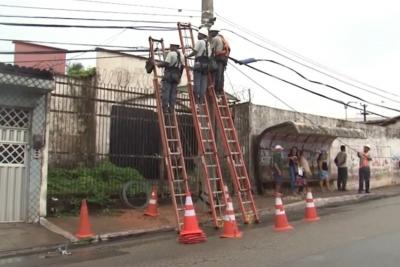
[0, 197, 400, 267]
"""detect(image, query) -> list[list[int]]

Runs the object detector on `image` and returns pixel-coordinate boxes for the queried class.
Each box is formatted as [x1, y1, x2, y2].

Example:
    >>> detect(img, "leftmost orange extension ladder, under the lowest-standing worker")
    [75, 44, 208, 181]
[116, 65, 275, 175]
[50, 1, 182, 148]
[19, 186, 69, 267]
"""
[149, 37, 189, 230]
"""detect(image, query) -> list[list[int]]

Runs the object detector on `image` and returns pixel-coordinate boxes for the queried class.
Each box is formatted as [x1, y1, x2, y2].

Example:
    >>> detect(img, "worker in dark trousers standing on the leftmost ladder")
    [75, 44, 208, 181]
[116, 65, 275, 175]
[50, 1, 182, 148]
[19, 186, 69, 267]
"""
[157, 44, 183, 113]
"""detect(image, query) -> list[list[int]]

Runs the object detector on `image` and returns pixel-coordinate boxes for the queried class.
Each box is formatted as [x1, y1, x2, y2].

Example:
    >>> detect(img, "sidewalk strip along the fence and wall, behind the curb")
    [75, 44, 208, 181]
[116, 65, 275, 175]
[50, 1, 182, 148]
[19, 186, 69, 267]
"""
[0, 186, 400, 258]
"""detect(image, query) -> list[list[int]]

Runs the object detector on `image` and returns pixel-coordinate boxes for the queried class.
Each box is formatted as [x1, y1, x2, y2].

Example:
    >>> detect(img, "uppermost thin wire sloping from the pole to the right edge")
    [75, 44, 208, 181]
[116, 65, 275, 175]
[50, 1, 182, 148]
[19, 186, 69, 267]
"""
[215, 12, 400, 100]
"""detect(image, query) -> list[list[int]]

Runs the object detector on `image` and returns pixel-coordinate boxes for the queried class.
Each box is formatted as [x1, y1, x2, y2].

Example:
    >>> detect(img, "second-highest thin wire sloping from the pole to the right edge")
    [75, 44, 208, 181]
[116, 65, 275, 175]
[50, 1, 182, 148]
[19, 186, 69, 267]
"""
[217, 17, 400, 103]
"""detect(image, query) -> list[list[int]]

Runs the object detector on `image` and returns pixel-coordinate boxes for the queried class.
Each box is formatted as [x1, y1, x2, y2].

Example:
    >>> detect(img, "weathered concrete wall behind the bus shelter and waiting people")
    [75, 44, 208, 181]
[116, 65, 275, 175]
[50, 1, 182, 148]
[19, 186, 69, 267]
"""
[234, 103, 400, 193]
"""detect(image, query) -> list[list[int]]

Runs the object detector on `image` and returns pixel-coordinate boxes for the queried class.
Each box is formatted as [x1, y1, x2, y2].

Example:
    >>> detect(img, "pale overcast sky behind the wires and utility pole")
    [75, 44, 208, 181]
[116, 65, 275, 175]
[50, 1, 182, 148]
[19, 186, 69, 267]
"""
[0, 0, 400, 119]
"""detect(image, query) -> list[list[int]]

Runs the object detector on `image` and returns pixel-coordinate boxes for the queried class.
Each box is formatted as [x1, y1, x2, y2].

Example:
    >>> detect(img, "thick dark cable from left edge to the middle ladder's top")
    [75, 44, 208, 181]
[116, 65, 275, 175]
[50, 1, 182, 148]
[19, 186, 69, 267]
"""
[0, 22, 176, 31]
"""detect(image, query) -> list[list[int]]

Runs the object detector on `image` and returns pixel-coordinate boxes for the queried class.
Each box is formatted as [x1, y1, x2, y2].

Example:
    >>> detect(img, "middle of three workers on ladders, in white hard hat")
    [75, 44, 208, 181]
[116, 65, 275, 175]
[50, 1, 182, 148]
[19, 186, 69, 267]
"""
[187, 28, 211, 104]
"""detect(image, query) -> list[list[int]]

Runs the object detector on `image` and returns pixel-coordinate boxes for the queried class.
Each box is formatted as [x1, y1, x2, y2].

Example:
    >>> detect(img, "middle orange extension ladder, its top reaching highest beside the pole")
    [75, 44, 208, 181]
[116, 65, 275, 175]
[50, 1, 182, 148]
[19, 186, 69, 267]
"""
[178, 23, 227, 227]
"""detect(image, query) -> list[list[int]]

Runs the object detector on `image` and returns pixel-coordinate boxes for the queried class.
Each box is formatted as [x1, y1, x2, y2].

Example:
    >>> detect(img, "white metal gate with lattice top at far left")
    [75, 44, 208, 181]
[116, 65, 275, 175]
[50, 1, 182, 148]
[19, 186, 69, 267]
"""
[0, 107, 30, 222]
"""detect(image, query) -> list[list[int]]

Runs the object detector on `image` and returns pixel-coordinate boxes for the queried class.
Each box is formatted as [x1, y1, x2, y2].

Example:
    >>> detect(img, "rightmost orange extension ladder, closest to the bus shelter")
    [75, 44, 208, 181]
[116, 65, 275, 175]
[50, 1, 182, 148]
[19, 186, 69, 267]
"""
[207, 74, 260, 223]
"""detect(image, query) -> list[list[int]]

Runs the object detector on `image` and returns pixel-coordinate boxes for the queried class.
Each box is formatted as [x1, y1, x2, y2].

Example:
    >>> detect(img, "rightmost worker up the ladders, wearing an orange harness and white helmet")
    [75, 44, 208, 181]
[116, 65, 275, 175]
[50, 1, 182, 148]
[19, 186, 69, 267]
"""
[210, 25, 230, 95]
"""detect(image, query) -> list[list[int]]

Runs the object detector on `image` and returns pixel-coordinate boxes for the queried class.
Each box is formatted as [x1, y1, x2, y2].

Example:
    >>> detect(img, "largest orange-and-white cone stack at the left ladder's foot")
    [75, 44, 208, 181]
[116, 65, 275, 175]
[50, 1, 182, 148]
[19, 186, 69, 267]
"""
[179, 193, 207, 244]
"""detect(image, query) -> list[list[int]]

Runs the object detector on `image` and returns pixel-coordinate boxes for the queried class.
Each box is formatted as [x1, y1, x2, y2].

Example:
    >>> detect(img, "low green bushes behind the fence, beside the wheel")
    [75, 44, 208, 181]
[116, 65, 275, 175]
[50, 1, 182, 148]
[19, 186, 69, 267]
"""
[48, 161, 147, 209]
